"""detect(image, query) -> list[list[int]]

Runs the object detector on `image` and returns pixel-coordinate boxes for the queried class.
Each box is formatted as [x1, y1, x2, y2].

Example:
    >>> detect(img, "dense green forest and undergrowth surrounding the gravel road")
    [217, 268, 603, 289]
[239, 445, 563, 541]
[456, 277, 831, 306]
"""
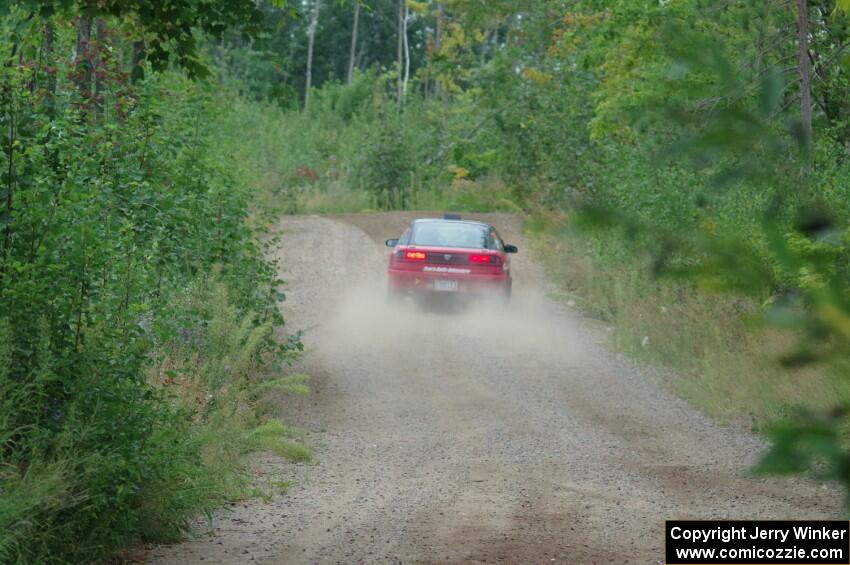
[0, 0, 850, 563]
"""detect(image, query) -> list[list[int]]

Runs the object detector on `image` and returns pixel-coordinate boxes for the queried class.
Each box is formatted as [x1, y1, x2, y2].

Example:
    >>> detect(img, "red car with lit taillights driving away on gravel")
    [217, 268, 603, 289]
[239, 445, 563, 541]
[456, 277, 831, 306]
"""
[386, 214, 517, 299]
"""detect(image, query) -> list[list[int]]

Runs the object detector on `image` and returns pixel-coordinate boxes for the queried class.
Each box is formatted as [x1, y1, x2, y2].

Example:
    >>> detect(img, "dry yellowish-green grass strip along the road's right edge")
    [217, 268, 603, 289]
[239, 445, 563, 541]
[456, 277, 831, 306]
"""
[526, 215, 850, 431]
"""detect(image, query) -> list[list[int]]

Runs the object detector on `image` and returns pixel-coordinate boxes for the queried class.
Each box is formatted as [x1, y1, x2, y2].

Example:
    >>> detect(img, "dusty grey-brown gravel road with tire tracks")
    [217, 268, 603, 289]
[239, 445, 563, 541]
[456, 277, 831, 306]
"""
[149, 213, 837, 565]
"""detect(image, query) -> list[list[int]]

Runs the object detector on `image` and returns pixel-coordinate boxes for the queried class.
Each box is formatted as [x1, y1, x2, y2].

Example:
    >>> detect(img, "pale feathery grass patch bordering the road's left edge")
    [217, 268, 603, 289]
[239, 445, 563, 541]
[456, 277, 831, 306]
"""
[134, 278, 312, 540]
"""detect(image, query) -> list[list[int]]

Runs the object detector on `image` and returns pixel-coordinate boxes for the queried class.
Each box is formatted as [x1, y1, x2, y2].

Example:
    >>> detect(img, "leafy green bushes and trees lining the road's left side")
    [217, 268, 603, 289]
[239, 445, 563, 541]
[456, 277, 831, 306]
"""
[0, 1, 310, 563]
